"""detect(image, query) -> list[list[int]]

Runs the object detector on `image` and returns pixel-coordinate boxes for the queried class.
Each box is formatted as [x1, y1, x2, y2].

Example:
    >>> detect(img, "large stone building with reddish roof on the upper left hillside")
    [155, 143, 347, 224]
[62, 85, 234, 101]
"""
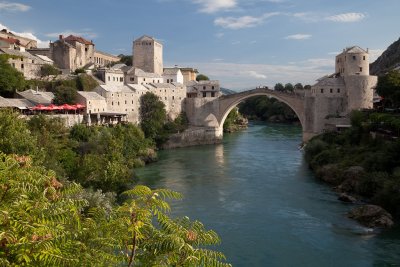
[50, 35, 95, 72]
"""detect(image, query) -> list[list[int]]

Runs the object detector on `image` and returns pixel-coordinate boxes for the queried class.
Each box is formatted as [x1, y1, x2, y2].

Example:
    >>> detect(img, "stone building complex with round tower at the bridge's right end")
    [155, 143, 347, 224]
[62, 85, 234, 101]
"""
[305, 46, 377, 137]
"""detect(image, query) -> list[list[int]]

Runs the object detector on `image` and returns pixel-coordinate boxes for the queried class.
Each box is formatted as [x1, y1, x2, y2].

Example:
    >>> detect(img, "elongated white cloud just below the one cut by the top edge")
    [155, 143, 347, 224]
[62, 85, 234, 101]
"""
[214, 12, 280, 30]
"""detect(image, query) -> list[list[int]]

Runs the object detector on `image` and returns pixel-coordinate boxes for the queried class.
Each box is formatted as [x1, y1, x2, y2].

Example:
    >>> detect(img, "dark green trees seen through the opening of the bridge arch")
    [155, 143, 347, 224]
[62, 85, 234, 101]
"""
[239, 96, 297, 122]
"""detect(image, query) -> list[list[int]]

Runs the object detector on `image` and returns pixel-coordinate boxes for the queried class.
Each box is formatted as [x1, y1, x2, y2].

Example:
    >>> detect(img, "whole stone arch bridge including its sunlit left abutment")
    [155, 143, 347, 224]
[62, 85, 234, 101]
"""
[186, 88, 315, 141]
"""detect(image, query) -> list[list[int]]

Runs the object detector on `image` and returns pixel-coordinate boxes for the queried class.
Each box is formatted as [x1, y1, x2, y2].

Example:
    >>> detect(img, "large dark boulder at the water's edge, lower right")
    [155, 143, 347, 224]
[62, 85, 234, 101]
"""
[348, 205, 394, 228]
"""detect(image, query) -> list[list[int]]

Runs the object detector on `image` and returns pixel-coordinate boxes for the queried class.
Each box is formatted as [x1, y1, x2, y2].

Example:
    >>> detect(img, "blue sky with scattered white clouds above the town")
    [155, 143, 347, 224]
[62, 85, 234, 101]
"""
[0, 0, 400, 91]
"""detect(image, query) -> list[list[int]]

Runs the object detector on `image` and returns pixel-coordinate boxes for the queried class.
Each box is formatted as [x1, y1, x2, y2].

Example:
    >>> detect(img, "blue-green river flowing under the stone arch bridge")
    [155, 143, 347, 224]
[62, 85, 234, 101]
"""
[137, 124, 400, 267]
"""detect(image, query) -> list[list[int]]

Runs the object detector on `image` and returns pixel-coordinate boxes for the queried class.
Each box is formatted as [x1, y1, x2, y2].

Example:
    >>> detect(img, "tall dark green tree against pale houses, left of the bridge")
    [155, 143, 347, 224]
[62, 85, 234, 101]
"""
[140, 92, 167, 140]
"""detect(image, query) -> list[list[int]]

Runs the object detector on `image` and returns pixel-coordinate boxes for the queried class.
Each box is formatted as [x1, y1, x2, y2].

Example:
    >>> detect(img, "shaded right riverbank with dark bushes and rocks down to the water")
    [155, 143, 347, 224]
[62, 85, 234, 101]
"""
[305, 114, 400, 228]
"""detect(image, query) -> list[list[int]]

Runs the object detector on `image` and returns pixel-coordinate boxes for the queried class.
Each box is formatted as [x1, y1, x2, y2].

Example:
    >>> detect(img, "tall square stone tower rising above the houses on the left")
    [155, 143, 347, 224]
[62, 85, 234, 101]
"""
[132, 35, 163, 75]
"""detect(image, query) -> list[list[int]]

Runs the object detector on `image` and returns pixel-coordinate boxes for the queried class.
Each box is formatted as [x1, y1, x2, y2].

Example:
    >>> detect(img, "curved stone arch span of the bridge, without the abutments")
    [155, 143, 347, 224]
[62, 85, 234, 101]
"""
[217, 88, 305, 136]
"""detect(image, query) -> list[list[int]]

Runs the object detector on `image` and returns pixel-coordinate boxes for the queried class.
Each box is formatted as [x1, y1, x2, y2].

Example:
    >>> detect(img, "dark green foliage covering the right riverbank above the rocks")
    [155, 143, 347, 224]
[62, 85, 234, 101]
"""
[305, 112, 400, 216]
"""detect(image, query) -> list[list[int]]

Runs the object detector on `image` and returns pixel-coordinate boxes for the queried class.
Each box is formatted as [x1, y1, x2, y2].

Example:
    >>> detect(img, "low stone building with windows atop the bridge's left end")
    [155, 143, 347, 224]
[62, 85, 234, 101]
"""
[186, 81, 222, 98]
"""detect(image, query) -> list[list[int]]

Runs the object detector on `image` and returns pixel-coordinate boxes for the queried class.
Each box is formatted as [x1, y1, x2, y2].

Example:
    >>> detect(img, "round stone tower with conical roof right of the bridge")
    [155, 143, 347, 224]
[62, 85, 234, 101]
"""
[335, 46, 377, 111]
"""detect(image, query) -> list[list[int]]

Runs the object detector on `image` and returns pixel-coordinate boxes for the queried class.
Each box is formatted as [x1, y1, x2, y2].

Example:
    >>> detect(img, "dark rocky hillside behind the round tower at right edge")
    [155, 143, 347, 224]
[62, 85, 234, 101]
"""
[369, 38, 400, 76]
